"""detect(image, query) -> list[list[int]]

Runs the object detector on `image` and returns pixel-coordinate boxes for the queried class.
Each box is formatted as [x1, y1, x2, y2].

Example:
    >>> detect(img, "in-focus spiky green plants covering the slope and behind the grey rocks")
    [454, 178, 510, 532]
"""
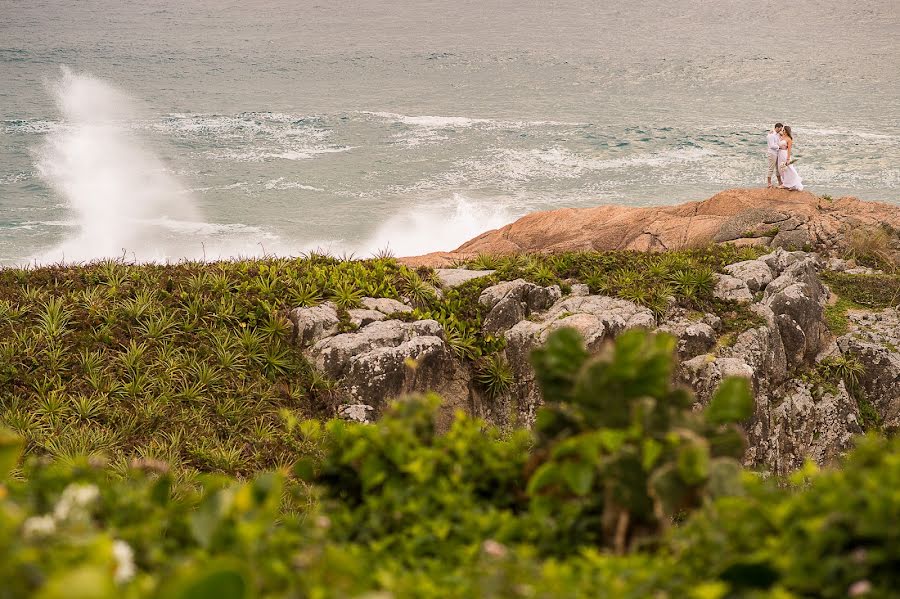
[0, 247, 758, 478]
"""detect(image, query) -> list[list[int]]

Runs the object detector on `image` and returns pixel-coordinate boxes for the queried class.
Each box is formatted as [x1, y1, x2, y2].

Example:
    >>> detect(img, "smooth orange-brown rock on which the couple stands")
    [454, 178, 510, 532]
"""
[403, 189, 900, 267]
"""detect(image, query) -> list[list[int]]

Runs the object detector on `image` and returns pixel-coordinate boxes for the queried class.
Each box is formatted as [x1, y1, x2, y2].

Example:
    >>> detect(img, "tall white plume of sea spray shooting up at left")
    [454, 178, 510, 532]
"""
[37, 69, 200, 261]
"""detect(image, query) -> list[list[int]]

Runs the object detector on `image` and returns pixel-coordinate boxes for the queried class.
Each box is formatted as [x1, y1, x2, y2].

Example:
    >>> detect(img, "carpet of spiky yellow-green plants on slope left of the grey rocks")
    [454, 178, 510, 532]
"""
[0, 255, 418, 474]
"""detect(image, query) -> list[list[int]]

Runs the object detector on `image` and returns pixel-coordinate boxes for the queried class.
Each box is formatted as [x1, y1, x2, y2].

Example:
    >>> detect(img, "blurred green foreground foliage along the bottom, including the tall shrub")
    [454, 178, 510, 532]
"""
[0, 331, 900, 599]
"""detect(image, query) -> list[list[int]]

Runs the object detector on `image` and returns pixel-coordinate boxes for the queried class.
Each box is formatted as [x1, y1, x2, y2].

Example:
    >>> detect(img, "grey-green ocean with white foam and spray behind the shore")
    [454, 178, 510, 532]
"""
[0, 0, 900, 266]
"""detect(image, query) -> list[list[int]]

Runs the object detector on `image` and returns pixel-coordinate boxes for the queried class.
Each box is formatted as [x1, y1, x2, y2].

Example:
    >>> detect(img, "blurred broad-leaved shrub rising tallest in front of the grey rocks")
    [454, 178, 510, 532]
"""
[528, 329, 753, 553]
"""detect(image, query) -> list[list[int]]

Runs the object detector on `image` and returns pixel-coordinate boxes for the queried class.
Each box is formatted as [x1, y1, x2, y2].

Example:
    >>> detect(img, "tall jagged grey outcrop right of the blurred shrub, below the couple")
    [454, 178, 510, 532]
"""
[679, 249, 861, 473]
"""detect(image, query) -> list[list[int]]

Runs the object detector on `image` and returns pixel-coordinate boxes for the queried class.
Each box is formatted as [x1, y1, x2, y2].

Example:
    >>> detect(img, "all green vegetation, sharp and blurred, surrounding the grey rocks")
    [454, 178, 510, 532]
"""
[0, 246, 900, 599]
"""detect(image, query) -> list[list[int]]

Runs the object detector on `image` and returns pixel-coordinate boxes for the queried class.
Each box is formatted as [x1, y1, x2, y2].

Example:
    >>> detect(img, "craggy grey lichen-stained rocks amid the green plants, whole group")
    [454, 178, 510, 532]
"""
[292, 248, 900, 473]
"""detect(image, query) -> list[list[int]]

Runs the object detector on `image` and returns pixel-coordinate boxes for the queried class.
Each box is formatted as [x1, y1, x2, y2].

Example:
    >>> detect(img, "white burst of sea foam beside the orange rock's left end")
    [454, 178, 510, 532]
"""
[357, 194, 521, 256]
